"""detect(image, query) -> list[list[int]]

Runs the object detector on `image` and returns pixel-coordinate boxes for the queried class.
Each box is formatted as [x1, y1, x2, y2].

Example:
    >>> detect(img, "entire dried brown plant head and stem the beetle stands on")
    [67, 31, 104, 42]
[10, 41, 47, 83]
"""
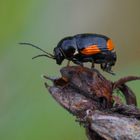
[44, 66, 140, 140]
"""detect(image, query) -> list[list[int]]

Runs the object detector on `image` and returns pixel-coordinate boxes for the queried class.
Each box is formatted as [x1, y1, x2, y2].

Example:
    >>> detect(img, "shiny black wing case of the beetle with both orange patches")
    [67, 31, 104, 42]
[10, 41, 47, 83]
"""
[77, 35, 114, 55]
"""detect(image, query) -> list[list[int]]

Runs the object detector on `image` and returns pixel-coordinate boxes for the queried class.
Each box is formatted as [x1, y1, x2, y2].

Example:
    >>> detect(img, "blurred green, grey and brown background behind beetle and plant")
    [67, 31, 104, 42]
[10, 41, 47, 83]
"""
[0, 0, 140, 140]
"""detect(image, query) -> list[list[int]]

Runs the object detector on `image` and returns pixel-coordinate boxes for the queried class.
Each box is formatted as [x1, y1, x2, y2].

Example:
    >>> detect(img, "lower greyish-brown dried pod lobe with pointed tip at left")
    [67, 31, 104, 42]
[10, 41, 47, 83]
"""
[45, 76, 101, 118]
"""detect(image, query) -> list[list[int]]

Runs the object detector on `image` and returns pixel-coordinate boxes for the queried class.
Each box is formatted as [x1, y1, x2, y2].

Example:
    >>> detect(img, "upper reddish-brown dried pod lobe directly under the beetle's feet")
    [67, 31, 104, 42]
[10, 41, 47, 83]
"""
[60, 66, 112, 106]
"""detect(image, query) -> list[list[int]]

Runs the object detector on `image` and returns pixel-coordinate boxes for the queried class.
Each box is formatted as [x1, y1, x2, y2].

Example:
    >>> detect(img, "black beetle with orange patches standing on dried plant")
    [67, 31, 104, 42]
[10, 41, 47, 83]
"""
[20, 33, 117, 74]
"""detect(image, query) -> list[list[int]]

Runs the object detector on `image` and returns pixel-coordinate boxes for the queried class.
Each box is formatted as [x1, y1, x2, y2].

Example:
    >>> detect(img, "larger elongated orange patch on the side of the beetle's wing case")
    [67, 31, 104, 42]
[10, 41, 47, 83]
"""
[81, 45, 101, 55]
